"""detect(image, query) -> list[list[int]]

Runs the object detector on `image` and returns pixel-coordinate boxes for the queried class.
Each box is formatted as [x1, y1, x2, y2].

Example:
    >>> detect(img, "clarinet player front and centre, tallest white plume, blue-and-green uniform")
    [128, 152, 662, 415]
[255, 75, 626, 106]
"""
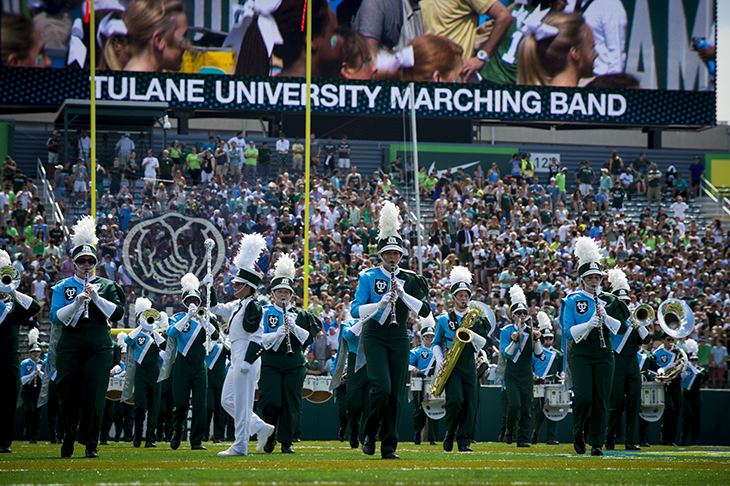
[350, 201, 431, 459]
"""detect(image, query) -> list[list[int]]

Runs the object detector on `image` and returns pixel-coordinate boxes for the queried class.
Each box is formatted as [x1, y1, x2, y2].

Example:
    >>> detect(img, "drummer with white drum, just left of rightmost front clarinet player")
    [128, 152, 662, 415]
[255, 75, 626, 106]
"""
[531, 311, 563, 445]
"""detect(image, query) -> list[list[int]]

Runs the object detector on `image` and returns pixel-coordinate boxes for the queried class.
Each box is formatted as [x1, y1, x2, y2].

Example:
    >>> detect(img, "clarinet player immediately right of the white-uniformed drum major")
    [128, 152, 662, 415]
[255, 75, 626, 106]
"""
[259, 254, 322, 454]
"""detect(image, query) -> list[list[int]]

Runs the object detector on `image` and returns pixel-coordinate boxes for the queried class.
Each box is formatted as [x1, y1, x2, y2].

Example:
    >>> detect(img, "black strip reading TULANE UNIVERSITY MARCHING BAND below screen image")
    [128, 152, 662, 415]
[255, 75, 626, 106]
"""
[0, 68, 715, 126]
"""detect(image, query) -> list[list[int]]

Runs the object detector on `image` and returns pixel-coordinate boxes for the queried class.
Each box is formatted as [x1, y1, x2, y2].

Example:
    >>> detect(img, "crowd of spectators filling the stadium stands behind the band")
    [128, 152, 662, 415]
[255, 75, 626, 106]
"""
[0, 133, 730, 387]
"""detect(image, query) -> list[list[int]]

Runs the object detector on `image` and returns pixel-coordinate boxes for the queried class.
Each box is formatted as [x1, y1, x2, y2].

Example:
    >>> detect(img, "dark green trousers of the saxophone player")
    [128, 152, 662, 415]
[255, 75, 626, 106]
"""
[445, 358, 479, 446]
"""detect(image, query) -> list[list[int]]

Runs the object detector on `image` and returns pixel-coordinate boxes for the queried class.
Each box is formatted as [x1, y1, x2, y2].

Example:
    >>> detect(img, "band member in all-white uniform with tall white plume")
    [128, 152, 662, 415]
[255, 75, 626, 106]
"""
[212, 233, 274, 456]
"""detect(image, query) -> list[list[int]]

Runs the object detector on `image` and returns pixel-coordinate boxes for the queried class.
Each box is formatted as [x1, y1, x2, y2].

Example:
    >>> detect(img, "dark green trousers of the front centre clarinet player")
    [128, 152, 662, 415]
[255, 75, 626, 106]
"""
[361, 332, 409, 454]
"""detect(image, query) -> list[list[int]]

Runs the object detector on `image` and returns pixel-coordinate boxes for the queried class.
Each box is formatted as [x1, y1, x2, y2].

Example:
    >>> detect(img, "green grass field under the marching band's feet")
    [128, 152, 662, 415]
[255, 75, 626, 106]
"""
[0, 442, 730, 485]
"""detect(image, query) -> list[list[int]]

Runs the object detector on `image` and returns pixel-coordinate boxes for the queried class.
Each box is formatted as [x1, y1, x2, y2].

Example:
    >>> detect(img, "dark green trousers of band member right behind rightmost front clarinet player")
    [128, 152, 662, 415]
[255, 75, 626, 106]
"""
[608, 353, 641, 445]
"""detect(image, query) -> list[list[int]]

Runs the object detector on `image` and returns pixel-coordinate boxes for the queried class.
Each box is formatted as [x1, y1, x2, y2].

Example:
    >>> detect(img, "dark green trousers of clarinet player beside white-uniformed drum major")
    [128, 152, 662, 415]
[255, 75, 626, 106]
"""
[259, 355, 307, 446]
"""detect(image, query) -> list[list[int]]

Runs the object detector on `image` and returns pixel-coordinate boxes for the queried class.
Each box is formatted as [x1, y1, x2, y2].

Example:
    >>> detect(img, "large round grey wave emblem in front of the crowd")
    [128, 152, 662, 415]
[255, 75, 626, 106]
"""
[122, 213, 226, 294]
